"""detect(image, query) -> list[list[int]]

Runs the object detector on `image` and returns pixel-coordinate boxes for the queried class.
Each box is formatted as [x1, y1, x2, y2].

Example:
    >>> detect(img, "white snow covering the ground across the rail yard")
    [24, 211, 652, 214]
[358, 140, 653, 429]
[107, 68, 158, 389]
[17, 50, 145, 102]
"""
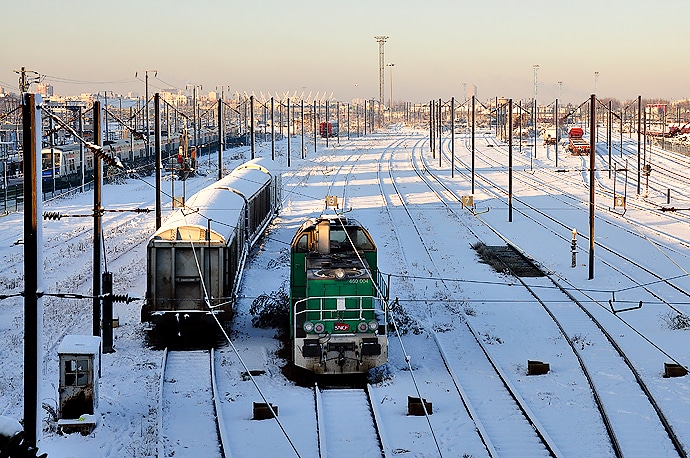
[0, 124, 690, 457]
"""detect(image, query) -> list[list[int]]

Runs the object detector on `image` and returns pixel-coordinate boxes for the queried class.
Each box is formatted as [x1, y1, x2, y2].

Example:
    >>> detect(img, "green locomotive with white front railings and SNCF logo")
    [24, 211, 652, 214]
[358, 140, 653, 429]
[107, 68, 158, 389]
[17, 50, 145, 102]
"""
[290, 215, 388, 374]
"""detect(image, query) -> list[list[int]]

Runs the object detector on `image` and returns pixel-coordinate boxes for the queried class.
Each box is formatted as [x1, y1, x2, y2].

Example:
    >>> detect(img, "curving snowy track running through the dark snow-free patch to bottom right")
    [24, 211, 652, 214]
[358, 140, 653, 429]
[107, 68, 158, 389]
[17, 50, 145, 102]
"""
[420, 139, 687, 456]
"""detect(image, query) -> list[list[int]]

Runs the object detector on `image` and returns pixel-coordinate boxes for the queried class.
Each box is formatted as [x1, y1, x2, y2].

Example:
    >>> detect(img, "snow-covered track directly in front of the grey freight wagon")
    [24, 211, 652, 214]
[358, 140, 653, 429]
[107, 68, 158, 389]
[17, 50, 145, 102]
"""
[158, 350, 227, 458]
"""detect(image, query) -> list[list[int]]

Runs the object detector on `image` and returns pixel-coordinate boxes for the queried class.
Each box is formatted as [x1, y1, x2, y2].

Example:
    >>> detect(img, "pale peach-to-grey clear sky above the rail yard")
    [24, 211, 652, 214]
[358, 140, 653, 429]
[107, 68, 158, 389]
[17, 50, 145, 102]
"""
[0, 0, 690, 103]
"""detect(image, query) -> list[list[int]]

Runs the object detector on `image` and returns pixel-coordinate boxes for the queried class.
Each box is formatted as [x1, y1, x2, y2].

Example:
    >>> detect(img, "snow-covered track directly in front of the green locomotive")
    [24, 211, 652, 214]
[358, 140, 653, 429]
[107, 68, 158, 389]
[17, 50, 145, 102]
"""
[314, 386, 384, 458]
